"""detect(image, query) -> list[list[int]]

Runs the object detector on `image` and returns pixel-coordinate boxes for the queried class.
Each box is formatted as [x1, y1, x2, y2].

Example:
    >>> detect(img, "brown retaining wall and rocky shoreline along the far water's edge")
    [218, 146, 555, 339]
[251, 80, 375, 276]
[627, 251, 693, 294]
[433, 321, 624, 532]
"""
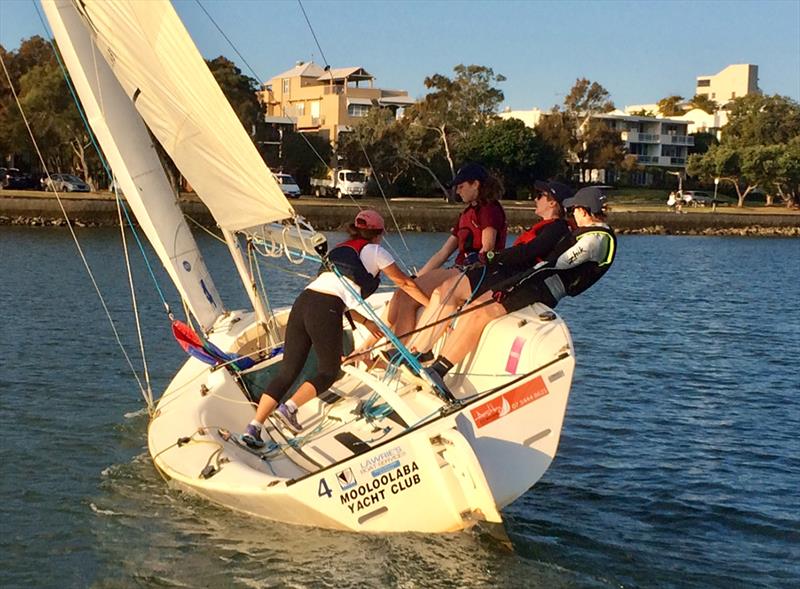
[0, 191, 800, 237]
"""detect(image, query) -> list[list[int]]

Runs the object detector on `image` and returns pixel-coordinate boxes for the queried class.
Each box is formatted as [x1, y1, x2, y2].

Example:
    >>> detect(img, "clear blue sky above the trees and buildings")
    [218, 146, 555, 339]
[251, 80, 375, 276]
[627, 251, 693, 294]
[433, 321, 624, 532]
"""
[0, 0, 800, 110]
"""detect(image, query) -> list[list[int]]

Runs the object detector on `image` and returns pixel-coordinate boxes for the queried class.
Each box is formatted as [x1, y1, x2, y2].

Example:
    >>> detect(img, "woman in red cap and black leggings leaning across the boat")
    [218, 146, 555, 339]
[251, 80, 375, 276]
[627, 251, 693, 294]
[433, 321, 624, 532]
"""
[241, 210, 429, 448]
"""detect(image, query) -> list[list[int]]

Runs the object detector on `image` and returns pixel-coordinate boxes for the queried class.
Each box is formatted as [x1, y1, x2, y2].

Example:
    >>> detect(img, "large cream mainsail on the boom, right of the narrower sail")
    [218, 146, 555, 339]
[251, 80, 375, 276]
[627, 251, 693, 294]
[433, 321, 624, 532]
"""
[65, 0, 294, 231]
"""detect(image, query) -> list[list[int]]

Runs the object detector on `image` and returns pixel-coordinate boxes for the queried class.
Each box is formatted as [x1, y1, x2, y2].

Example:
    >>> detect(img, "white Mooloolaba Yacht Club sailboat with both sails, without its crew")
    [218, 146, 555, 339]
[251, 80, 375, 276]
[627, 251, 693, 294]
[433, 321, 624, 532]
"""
[42, 0, 575, 533]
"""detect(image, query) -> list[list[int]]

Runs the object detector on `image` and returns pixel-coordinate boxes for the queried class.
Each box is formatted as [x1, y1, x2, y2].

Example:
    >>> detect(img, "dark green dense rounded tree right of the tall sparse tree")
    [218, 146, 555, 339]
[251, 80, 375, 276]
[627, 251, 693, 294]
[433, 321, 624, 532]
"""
[459, 119, 561, 196]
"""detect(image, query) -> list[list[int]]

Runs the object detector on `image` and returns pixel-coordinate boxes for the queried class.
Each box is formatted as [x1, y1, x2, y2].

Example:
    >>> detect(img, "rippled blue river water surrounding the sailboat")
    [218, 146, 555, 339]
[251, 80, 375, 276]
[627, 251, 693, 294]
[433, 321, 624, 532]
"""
[0, 227, 800, 589]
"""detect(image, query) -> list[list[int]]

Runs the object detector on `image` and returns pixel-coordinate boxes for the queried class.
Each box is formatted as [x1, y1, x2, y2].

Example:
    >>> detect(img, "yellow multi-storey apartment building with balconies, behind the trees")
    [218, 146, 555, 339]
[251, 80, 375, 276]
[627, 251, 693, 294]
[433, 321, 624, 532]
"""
[261, 61, 415, 144]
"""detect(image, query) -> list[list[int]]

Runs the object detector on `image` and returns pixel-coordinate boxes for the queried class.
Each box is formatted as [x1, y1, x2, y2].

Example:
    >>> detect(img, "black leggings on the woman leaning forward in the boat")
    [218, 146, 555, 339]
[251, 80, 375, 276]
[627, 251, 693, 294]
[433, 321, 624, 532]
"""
[264, 290, 345, 403]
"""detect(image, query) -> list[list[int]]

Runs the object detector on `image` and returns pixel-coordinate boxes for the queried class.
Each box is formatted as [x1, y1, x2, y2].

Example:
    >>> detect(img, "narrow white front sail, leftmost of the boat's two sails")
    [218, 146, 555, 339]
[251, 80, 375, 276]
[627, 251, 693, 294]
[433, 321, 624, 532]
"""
[42, 0, 224, 331]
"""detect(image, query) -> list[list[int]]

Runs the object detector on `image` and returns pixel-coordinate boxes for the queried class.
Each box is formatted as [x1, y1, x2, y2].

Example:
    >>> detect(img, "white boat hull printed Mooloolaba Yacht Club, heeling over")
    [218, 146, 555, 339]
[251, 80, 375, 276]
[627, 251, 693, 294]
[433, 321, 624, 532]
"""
[148, 296, 574, 532]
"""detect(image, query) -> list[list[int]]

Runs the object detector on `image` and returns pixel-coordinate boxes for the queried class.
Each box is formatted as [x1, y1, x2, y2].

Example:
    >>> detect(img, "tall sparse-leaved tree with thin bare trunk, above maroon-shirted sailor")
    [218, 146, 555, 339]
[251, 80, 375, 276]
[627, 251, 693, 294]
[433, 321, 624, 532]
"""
[405, 64, 506, 177]
